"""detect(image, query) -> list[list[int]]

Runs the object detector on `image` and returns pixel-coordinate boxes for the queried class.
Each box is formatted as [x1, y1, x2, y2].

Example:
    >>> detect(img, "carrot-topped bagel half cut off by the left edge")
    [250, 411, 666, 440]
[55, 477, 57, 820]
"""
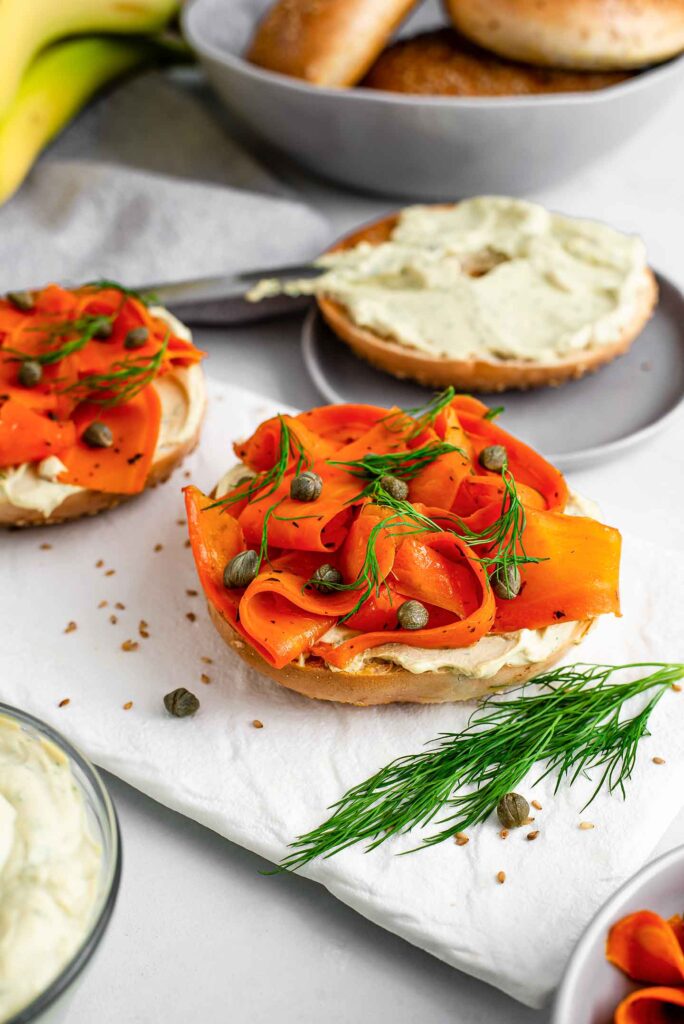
[0, 282, 205, 526]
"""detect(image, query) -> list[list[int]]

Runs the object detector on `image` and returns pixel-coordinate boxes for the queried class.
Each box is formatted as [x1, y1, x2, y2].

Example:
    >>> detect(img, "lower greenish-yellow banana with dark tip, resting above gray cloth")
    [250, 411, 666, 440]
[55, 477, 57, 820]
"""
[0, 37, 163, 203]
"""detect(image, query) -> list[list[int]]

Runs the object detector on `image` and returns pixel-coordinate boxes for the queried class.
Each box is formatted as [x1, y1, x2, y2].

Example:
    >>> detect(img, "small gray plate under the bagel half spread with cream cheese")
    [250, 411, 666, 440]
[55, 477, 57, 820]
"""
[302, 275, 684, 469]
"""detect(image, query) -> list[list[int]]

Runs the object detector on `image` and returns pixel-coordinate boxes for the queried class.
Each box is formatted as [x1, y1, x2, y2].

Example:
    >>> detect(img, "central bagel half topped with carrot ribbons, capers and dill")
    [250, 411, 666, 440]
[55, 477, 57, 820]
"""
[185, 389, 621, 705]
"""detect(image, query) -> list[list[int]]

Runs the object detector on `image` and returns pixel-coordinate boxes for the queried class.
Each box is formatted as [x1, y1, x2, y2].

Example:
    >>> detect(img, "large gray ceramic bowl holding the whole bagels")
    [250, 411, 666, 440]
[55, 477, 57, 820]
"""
[183, 0, 684, 200]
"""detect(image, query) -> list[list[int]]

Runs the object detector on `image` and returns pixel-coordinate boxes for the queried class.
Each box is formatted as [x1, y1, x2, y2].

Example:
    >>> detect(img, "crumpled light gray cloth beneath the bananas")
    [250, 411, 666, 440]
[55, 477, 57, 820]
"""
[0, 72, 330, 290]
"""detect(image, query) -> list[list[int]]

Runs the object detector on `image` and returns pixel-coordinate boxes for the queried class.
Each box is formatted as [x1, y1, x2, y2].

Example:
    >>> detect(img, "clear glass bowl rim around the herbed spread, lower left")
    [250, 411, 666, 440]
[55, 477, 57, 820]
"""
[0, 702, 121, 1024]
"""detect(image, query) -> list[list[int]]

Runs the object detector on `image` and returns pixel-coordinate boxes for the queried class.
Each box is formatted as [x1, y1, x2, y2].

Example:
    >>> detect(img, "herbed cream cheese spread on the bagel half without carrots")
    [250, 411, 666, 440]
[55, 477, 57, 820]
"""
[251, 196, 646, 364]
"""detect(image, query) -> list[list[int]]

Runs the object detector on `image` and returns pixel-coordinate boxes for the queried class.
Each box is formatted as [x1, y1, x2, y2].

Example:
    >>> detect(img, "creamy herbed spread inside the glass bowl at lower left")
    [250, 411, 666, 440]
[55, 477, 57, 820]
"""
[0, 716, 101, 1022]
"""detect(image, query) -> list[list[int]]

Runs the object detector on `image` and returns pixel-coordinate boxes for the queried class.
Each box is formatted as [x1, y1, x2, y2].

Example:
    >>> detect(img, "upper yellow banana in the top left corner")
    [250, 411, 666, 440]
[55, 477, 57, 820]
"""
[0, 0, 179, 115]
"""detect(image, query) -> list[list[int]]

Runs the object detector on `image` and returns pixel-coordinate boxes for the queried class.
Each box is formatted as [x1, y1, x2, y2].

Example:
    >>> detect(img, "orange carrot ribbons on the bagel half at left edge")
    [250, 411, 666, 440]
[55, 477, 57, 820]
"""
[0, 283, 202, 494]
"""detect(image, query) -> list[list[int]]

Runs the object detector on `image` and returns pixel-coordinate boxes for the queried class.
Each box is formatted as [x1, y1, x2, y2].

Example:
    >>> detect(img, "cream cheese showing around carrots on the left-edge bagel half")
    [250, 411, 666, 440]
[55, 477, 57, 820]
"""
[0, 306, 206, 518]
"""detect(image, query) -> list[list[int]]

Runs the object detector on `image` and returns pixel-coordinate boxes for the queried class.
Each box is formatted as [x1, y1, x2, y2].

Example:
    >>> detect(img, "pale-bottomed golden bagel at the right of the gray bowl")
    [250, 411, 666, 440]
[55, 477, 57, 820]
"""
[444, 0, 684, 71]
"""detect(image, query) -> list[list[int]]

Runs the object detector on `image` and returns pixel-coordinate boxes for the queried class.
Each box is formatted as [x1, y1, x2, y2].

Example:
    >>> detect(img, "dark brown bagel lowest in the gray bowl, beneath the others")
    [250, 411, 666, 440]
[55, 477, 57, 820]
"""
[361, 29, 628, 96]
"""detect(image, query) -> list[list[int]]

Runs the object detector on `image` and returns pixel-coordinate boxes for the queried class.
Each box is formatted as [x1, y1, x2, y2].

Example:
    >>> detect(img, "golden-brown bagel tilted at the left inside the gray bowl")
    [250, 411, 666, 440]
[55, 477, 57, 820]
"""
[247, 0, 416, 87]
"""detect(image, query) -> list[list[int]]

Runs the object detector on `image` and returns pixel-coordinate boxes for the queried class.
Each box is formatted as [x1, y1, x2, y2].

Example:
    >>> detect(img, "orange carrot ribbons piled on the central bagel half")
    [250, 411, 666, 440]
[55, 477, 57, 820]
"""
[185, 391, 619, 669]
